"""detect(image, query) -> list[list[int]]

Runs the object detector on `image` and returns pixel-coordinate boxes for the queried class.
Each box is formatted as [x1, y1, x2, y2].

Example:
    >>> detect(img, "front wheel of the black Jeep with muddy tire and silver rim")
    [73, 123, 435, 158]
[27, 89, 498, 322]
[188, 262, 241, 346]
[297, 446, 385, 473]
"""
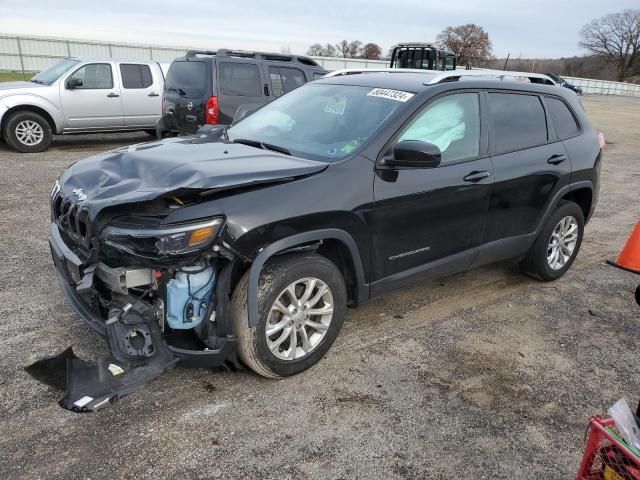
[230, 253, 347, 378]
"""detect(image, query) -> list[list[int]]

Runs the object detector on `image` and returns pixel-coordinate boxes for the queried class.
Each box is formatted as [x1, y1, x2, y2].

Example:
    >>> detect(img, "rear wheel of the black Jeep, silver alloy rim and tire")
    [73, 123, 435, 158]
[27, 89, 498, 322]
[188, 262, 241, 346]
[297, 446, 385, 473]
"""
[520, 201, 584, 282]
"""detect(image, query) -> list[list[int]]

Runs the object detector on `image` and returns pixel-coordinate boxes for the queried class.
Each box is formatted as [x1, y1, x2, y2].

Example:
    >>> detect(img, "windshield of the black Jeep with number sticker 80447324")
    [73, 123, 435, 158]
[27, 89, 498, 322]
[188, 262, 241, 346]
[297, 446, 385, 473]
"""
[228, 84, 413, 161]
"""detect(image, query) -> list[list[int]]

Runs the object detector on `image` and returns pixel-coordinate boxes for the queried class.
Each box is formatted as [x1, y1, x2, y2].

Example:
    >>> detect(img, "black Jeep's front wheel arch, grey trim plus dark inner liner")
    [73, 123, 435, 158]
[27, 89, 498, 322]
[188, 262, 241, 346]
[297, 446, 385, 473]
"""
[247, 228, 369, 328]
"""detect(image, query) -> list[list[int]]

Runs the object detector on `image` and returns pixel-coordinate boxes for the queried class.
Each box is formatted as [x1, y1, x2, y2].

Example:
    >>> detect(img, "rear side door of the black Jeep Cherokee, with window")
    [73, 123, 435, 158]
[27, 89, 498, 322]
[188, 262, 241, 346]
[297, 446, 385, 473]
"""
[483, 91, 571, 243]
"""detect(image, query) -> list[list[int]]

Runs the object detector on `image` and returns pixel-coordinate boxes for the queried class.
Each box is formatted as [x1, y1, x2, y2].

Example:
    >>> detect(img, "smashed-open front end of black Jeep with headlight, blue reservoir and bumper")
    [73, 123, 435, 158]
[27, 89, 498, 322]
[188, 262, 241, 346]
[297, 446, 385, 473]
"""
[27, 187, 246, 412]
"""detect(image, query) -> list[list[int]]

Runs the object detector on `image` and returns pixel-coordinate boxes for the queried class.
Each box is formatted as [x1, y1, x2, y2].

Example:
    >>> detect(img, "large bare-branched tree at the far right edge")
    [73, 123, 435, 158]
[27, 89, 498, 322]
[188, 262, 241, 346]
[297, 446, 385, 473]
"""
[578, 9, 640, 82]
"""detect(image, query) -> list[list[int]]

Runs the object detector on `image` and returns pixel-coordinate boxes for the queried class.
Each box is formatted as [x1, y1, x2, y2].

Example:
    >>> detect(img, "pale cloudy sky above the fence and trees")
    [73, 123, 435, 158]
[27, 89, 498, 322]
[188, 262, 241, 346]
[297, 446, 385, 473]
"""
[0, 0, 640, 58]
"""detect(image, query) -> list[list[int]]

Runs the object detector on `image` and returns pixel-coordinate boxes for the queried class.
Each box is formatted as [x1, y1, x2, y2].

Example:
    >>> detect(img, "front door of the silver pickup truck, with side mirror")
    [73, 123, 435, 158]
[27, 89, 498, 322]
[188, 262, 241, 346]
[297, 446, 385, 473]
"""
[60, 63, 124, 130]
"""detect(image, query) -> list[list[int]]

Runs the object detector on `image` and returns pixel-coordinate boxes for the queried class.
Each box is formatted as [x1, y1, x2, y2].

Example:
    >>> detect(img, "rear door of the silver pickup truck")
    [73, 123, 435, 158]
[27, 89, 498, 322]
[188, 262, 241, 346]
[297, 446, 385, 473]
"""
[118, 63, 163, 127]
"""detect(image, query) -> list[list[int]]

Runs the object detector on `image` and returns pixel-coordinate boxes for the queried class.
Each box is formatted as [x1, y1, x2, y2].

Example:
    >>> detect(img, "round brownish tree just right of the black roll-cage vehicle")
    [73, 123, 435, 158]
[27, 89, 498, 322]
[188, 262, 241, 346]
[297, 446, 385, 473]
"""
[436, 23, 493, 65]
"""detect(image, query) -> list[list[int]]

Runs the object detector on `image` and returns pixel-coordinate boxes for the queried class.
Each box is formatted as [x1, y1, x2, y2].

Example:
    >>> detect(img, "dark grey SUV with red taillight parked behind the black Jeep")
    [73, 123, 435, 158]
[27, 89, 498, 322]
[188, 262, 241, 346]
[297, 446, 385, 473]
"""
[157, 50, 327, 138]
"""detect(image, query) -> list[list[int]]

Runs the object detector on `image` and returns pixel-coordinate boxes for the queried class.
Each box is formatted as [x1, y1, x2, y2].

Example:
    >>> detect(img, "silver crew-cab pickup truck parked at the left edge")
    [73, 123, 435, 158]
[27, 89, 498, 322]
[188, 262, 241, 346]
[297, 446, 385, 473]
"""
[0, 58, 168, 153]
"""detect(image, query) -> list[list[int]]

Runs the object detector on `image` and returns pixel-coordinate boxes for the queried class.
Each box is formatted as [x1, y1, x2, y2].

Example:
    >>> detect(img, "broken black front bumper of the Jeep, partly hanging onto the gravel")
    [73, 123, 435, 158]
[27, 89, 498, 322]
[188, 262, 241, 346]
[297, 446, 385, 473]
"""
[27, 223, 239, 412]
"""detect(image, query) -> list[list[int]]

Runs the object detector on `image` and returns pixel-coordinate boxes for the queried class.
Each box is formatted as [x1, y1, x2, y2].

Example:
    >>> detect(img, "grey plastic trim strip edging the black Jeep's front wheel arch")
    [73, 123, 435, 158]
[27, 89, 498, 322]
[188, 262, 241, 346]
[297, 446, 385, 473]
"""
[247, 228, 369, 328]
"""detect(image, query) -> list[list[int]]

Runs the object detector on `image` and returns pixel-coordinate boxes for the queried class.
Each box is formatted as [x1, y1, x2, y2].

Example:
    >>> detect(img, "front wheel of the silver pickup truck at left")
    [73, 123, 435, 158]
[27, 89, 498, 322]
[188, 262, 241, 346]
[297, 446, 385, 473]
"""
[2, 111, 53, 153]
